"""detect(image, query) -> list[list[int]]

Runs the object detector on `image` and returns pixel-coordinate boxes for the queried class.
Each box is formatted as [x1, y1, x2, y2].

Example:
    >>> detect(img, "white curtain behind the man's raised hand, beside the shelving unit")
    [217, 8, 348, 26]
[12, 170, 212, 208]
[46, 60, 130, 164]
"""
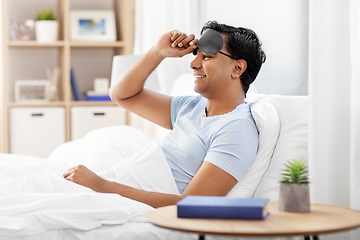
[134, 0, 203, 94]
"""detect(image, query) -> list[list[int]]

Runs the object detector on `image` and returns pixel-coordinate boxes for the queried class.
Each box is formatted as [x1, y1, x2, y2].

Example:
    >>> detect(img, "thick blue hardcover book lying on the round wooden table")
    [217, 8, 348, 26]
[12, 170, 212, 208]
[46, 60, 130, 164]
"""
[176, 196, 269, 219]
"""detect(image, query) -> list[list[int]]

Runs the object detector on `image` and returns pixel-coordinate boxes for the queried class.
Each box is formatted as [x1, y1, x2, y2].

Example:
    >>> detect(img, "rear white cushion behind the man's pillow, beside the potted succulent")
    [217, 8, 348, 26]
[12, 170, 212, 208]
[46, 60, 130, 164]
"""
[247, 94, 308, 201]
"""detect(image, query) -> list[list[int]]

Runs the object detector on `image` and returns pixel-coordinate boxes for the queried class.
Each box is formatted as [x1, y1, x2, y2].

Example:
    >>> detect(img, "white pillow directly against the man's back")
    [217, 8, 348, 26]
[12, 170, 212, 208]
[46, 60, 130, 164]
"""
[227, 102, 280, 198]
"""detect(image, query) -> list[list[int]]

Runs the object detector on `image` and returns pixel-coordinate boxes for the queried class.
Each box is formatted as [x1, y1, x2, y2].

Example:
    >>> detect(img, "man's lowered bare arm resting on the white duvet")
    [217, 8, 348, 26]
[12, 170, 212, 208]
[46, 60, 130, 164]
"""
[64, 162, 237, 208]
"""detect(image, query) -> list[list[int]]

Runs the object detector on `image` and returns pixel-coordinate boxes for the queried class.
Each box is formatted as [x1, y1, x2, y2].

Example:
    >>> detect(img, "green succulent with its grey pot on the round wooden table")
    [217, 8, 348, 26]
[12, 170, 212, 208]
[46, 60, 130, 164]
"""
[279, 160, 310, 212]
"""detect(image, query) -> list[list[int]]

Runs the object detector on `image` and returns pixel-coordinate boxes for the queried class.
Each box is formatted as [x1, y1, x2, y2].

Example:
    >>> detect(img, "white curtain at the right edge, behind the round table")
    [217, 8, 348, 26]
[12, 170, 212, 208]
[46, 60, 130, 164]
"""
[309, 0, 360, 239]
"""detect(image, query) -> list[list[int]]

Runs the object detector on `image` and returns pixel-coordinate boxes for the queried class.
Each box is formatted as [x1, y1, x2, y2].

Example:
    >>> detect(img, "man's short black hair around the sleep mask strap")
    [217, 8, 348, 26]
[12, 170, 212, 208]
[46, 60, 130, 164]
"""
[201, 21, 266, 94]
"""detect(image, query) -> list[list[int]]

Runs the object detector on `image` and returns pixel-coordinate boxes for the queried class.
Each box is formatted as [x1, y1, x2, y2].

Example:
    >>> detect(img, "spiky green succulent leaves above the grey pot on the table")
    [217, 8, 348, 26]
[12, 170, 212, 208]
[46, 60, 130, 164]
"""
[281, 159, 309, 184]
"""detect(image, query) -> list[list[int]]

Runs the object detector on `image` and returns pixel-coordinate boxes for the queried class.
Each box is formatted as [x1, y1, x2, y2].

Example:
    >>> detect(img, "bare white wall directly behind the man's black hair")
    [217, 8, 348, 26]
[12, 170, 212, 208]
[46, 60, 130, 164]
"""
[200, 0, 309, 95]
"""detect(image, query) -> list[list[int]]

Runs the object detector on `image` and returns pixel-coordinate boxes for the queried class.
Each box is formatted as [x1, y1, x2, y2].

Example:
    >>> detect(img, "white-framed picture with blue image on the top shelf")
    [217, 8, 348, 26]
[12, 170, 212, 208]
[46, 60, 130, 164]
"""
[70, 10, 116, 42]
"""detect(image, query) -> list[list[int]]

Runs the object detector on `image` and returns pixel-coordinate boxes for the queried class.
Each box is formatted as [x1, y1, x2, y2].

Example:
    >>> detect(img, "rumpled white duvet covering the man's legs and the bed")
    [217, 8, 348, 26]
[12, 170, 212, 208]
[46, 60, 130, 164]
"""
[0, 126, 178, 236]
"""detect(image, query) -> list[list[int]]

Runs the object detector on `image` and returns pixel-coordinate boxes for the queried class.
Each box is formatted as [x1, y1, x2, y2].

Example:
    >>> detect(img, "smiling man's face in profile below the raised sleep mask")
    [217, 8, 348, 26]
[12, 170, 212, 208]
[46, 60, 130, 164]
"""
[190, 40, 235, 99]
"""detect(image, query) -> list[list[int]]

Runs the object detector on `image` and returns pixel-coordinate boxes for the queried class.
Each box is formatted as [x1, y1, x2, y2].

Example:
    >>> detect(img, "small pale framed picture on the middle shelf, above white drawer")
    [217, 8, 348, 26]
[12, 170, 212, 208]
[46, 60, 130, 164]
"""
[15, 80, 50, 102]
